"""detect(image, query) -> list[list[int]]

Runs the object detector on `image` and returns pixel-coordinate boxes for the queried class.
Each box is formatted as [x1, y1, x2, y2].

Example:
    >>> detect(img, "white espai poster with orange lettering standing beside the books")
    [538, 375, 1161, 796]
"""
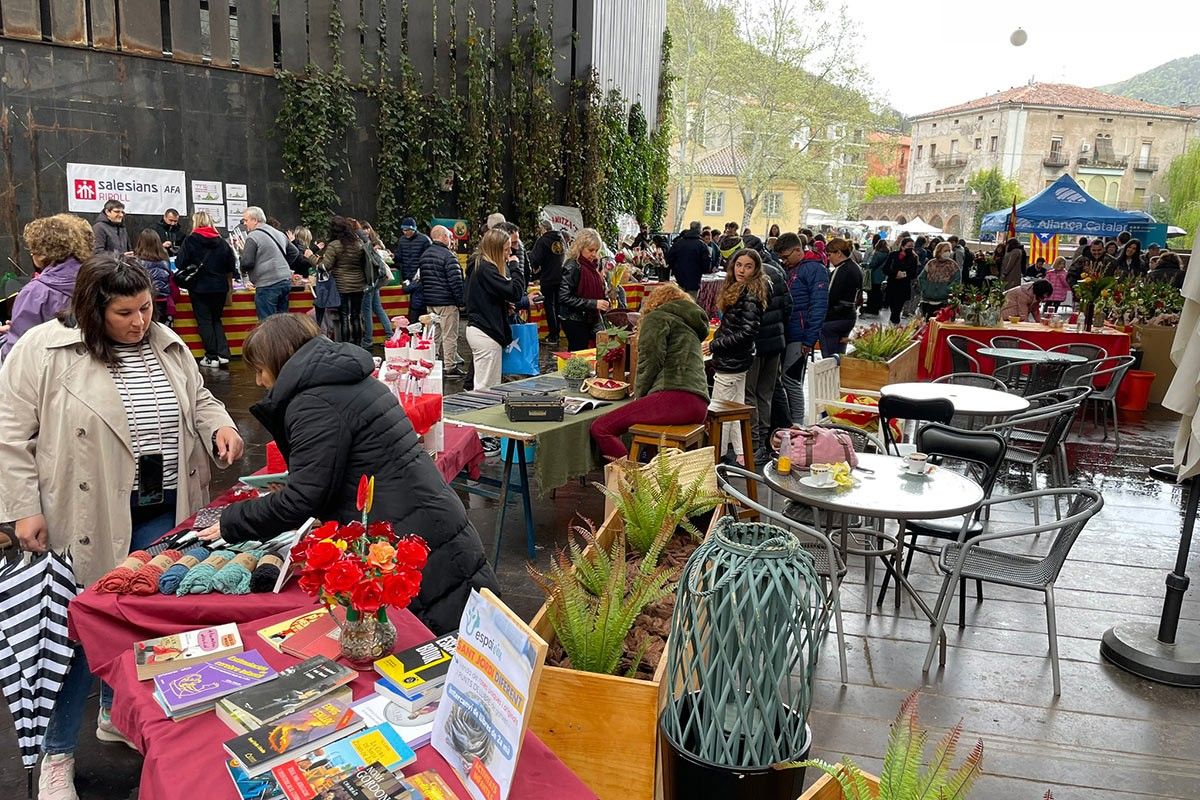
[433, 589, 546, 800]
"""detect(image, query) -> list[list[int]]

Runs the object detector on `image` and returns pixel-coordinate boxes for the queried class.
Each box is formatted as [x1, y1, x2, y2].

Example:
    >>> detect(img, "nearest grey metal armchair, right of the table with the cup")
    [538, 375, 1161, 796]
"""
[922, 487, 1104, 697]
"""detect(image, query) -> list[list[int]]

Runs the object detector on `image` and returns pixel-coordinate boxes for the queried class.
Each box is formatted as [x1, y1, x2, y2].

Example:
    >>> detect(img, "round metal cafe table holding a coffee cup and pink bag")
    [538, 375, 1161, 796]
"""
[763, 453, 984, 663]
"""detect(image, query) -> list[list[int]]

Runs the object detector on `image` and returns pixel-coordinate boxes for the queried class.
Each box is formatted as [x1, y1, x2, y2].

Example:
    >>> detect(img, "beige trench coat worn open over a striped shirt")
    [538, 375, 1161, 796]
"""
[0, 320, 236, 587]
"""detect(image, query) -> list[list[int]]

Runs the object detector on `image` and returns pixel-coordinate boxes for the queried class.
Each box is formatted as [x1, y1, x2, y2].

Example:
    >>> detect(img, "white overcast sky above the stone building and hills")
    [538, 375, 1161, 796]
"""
[811, 0, 1200, 114]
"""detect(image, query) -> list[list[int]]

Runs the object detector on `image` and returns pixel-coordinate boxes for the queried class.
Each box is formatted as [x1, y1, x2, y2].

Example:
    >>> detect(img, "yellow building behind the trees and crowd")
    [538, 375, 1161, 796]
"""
[666, 148, 804, 239]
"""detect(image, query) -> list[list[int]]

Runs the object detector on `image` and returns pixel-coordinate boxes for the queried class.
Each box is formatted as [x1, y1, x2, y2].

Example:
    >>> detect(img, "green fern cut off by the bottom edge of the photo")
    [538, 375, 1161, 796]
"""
[794, 692, 979, 800]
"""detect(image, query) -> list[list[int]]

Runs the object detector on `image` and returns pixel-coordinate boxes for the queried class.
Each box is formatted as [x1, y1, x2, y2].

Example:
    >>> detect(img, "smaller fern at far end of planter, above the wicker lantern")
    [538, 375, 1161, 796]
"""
[596, 450, 721, 556]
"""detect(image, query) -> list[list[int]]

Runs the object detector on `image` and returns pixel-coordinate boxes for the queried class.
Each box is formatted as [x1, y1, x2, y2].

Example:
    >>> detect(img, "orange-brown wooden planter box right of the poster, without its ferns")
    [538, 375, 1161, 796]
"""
[529, 512, 667, 800]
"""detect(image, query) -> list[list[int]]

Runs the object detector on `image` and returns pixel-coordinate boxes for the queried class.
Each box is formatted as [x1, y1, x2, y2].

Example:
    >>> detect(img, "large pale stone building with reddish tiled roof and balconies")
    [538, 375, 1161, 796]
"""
[906, 83, 1200, 210]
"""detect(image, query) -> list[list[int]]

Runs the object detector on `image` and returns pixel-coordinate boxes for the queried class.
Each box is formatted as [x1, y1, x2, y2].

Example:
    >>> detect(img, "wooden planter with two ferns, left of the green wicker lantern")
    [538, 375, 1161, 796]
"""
[529, 456, 719, 800]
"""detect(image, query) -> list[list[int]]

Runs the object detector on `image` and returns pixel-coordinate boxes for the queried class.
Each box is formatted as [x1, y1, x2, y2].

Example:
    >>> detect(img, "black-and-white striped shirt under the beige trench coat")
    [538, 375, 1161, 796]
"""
[109, 342, 180, 492]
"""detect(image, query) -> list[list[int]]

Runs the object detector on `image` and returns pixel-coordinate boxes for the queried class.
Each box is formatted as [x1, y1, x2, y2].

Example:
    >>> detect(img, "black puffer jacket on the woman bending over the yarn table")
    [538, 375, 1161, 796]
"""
[221, 337, 499, 633]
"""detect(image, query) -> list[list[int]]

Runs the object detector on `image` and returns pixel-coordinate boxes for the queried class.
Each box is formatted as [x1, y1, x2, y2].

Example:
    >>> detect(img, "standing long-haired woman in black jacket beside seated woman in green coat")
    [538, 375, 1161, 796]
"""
[703, 247, 769, 464]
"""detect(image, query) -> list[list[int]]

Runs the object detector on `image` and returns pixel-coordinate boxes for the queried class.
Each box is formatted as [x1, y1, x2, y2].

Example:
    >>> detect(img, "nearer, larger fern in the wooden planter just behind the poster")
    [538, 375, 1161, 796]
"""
[527, 519, 671, 675]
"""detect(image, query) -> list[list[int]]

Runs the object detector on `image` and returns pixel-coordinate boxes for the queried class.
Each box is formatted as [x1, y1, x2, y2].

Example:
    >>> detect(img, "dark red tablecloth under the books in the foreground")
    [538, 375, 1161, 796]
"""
[70, 597, 596, 800]
